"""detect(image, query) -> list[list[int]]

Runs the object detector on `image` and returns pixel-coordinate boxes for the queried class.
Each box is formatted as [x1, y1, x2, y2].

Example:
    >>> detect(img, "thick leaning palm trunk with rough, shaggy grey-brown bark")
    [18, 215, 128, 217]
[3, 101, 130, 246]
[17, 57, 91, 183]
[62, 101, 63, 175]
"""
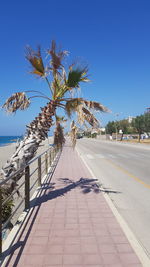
[1, 101, 56, 186]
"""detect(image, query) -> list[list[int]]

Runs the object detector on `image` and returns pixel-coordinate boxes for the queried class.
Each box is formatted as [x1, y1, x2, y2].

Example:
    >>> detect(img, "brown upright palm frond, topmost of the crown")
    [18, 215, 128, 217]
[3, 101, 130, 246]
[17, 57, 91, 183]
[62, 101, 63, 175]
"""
[47, 40, 68, 71]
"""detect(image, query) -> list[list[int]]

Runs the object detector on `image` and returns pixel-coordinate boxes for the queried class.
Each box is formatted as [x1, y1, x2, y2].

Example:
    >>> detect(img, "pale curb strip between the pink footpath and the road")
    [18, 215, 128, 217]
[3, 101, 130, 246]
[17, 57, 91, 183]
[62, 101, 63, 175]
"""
[76, 147, 150, 267]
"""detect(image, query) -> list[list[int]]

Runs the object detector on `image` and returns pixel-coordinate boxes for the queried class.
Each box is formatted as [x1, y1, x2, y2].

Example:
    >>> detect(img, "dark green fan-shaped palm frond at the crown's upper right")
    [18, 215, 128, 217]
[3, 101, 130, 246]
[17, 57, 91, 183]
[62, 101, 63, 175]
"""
[66, 67, 89, 88]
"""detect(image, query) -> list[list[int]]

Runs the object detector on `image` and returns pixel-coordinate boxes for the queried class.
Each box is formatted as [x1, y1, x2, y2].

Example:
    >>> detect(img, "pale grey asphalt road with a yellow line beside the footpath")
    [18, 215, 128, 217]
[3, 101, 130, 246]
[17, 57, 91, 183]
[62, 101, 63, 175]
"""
[77, 138, 150, 257]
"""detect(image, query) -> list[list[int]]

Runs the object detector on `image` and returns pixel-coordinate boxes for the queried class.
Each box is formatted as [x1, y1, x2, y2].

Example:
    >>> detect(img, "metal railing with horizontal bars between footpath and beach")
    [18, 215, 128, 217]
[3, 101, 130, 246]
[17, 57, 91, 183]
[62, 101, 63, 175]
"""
[0, 147, 58, 254]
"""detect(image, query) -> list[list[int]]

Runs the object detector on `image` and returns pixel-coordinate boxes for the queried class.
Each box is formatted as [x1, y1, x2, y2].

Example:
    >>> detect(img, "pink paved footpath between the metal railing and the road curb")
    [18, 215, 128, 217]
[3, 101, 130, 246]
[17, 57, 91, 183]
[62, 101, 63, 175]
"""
[2, 146, 142, 267]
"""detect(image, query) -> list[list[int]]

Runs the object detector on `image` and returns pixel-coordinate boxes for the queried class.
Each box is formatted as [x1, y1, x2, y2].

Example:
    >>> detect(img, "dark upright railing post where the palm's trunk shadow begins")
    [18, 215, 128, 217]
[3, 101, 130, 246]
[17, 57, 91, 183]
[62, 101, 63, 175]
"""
[25, 166, 30, 209]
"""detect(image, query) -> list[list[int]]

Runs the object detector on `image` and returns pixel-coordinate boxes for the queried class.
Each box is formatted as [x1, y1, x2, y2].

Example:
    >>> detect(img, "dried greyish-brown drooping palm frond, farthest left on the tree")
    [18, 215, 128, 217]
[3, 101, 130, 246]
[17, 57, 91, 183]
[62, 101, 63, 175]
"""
[2, 92, 30, 113]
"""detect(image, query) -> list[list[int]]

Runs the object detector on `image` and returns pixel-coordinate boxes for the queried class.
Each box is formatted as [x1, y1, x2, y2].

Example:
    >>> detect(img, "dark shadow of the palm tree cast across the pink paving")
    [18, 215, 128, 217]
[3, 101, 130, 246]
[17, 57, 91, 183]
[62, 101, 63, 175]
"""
[30, 178, 120, 207]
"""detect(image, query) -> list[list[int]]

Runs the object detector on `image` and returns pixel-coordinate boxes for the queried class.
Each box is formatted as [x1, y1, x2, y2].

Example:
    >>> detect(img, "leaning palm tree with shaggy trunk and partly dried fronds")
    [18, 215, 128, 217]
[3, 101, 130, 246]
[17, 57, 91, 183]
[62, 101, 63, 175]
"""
[1, 41, 108, 186]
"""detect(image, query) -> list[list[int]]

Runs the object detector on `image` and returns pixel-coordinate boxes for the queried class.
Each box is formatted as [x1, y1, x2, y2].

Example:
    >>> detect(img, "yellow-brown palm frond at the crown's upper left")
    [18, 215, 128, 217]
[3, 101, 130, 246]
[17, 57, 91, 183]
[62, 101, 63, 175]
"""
[26, 46, 46, 77]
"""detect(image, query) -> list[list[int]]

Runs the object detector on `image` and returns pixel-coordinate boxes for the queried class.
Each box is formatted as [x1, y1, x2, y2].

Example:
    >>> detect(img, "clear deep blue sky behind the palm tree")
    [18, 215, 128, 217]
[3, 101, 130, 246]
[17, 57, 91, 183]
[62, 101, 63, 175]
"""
[0, 0, 150, 135]
